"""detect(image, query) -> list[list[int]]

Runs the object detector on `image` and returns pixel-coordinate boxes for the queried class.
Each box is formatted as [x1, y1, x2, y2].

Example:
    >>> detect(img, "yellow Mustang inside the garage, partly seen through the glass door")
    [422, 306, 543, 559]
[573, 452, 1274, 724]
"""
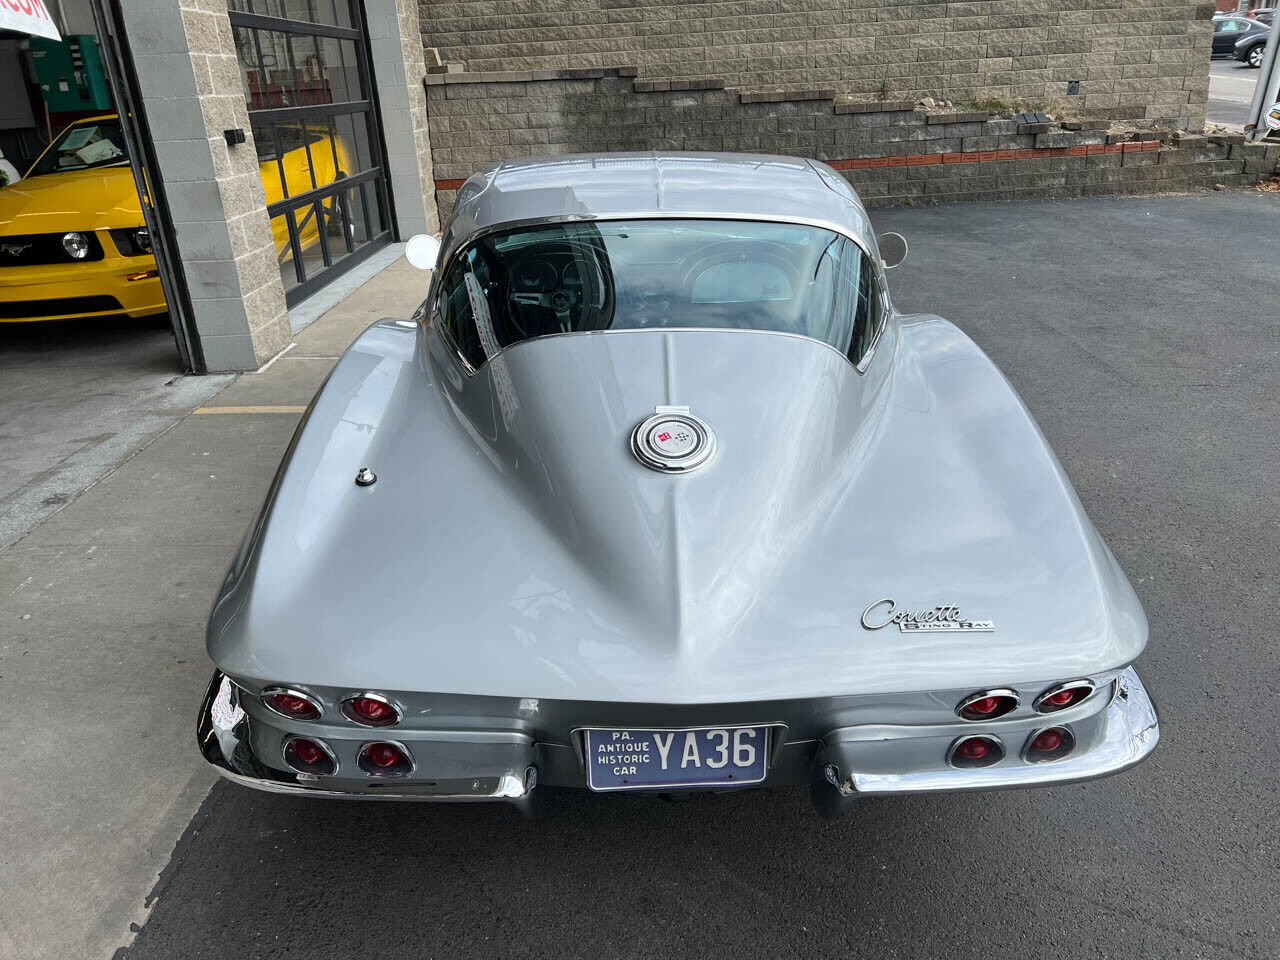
[0, 114, 351, 323]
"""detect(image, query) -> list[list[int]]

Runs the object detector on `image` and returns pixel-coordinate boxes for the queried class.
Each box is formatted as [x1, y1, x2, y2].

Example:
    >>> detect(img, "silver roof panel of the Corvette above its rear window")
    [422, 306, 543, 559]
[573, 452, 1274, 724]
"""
[443, 151, 872, 267]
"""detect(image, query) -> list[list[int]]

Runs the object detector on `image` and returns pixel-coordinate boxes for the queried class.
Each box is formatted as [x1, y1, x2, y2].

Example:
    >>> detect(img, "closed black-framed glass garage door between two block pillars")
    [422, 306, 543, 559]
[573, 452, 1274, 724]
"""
[230, 0, 392, 306]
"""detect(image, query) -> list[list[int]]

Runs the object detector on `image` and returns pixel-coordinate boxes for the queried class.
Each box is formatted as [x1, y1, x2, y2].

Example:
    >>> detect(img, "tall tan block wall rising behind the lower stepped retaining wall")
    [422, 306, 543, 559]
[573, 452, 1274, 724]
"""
[420, 0, 1213, 128]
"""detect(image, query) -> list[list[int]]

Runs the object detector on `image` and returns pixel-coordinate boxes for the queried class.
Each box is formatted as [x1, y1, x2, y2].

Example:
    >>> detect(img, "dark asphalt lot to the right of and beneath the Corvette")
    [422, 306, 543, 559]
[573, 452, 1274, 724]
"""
[87, 191, 1280, 960]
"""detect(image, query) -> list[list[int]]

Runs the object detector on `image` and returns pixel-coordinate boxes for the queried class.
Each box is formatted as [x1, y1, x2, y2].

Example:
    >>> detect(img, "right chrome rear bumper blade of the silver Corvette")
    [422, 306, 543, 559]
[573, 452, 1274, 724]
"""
[852, 667, 1160, 795]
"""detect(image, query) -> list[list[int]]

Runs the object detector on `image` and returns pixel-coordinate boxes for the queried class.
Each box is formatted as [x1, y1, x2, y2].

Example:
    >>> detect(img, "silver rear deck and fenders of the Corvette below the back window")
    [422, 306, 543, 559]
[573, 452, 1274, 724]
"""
[209, 317, 1147, 703]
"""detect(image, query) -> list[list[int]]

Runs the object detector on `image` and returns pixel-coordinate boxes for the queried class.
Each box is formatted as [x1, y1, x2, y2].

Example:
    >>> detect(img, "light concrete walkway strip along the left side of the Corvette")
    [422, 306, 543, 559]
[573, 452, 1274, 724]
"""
[0, 260, 426, 960]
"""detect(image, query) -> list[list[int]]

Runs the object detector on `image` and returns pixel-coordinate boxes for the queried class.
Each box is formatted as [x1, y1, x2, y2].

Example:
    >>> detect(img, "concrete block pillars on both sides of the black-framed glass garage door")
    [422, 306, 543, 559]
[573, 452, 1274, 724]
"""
[123, 0, 439, 371]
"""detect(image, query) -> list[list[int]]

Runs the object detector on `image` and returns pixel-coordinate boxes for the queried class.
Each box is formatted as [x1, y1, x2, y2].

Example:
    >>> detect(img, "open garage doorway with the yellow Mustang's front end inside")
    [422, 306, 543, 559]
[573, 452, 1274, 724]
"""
[0, 0, 202, 371]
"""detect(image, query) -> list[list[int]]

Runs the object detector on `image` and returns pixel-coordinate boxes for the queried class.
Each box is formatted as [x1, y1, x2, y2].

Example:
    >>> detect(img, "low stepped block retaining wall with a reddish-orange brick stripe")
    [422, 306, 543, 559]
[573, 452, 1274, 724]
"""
[428, 68, 1280, 218]
